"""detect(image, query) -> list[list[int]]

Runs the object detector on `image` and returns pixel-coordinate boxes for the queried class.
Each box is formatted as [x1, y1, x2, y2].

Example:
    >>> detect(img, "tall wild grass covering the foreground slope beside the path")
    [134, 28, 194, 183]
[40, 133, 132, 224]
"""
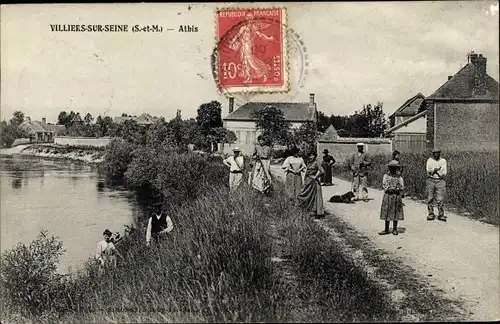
[2, 182, 396, 322]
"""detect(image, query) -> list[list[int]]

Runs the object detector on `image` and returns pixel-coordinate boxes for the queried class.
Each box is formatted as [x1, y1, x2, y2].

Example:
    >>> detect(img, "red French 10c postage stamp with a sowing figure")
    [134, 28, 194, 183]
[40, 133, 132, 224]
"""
[215, 8, 289, 92]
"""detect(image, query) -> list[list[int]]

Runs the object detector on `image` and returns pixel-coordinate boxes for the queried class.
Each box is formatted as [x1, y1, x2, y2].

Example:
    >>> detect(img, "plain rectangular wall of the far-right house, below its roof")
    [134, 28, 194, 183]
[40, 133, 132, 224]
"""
[434, 102, 499, 151]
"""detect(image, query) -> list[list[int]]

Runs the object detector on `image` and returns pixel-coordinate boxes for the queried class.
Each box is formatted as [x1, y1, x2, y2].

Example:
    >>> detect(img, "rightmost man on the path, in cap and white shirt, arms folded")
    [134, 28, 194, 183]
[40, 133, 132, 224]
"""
[426, 148, 448, 222]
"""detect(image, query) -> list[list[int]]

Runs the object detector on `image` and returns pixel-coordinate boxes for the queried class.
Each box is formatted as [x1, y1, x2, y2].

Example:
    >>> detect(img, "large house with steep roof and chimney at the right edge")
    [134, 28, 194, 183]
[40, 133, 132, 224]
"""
[419, 52, 499, 151]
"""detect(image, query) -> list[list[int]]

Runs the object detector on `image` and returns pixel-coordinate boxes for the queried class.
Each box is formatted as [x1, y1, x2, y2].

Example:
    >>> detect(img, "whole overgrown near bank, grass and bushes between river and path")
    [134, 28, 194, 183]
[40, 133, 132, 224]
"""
[1, 137, 399, 323]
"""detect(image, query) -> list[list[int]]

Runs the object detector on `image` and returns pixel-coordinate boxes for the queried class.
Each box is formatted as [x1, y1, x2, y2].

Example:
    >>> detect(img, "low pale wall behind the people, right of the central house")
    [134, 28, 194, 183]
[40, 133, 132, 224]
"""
[317, 137, 392, 163]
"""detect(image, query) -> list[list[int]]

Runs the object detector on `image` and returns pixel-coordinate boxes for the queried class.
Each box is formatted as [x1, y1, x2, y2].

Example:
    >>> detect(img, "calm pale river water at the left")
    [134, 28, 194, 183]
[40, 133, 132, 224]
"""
[0, 156, 143, 273]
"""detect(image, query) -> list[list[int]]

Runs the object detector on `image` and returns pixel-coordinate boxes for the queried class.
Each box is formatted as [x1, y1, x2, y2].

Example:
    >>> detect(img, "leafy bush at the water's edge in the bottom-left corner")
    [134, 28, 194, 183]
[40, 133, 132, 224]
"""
[0, 231, 66, 317]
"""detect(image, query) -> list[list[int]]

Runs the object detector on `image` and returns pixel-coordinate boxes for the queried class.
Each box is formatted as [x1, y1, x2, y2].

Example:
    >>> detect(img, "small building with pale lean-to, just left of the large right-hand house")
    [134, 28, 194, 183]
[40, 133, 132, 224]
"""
[385, 92, 427, 152]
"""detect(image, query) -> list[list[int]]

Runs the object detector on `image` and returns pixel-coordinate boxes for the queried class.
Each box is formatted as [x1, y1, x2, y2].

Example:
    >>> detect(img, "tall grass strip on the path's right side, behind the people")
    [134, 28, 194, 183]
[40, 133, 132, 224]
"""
[333, 152, 500, 225]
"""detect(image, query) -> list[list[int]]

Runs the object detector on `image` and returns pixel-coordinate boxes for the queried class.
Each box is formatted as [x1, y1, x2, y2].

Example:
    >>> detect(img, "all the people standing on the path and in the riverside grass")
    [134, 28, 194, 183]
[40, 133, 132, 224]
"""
[95, 142, 448, 275]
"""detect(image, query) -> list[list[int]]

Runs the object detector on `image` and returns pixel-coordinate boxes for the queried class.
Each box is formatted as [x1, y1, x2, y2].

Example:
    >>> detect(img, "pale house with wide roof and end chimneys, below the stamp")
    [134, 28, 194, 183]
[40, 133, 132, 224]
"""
[223, 93, 318, 154]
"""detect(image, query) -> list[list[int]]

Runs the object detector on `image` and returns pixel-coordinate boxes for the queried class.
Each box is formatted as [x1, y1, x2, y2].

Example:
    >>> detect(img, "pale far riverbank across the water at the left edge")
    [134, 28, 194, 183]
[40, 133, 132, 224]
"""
[0, 144, 105, 164]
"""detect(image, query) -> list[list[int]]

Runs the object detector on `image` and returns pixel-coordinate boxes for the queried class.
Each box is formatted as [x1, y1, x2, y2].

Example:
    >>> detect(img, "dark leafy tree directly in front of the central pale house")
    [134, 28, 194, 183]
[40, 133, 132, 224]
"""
[253, 105, 292, 145]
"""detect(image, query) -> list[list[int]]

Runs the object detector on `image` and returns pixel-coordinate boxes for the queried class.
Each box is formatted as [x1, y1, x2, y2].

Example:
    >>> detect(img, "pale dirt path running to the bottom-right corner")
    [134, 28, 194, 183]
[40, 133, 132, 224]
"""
[272, 165, 500, 321]
